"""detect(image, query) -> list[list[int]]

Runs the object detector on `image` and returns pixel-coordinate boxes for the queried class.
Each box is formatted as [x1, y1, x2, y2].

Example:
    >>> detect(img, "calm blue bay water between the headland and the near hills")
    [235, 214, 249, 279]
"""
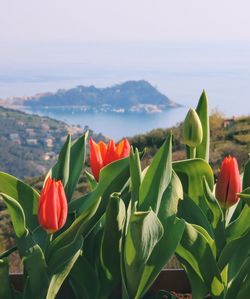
[21, 107, 187, 140]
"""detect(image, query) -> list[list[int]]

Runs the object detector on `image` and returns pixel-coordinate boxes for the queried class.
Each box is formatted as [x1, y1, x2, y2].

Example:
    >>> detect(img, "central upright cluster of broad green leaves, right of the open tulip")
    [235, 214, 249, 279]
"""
[122, 135, 184, 298]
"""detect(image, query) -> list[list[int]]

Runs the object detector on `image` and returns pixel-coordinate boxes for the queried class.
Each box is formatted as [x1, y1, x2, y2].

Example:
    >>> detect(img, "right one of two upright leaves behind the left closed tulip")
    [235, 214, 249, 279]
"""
[65, 133, 88, 201]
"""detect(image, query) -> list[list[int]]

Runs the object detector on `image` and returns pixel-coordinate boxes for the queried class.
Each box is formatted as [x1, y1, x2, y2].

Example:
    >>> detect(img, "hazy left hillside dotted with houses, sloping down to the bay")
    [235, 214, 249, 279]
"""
[0, 107, 105, 178]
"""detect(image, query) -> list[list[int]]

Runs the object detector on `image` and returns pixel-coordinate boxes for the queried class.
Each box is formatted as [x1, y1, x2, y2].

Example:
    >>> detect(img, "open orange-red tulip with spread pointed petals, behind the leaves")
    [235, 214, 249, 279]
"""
[89, 138, 130, 181]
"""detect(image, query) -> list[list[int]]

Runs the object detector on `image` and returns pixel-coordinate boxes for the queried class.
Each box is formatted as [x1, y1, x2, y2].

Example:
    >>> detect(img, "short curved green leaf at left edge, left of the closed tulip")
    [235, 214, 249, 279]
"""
[0, 193, 28, 238]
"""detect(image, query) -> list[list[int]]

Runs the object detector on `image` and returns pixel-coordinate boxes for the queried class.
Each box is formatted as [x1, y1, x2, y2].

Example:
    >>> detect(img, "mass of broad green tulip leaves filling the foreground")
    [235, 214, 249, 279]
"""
[0, 92, 250, 299]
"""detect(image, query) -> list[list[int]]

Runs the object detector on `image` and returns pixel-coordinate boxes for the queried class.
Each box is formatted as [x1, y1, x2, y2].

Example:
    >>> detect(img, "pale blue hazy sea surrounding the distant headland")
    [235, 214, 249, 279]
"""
[0, 41, 250, 140]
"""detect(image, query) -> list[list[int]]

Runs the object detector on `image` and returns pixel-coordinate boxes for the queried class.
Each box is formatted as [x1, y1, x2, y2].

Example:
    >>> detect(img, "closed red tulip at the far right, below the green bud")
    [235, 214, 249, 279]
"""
[215, 156, 242, 208]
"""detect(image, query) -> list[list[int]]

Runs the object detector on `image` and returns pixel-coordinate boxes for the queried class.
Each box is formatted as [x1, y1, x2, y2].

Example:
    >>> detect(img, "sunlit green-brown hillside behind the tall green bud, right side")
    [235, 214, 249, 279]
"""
[129, 112, 250, 174]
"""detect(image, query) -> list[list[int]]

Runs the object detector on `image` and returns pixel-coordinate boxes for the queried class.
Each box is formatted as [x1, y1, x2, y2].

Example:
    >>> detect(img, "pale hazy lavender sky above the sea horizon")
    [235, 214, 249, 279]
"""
[0, 0, 250, 41]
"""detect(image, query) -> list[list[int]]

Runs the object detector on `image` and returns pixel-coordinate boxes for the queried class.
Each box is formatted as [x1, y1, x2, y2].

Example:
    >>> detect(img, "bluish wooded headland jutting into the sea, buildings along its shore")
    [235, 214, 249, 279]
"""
[11, 80, 179, 113]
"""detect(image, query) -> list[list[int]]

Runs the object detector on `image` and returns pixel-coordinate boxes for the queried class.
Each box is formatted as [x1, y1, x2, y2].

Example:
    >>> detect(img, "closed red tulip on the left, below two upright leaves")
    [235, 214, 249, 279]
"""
[38, 177, 68, 234]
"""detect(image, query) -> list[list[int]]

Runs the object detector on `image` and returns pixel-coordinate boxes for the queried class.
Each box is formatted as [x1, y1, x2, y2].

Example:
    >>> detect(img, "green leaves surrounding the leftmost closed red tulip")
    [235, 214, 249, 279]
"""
[0, 136, 106, 299]
